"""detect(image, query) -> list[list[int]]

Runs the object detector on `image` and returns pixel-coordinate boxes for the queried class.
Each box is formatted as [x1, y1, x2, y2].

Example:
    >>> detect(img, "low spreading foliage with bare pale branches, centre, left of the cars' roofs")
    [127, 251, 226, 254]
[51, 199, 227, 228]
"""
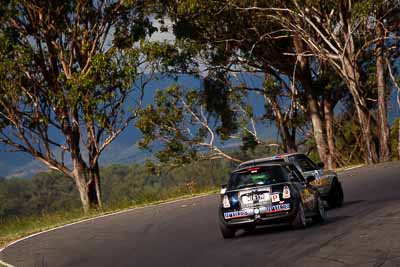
[136, 74, 262, 166]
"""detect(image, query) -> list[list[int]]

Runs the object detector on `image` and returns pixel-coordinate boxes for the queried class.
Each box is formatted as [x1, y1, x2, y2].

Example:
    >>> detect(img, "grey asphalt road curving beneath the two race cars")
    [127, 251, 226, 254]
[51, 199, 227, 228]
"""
[0, 163, 400, 267]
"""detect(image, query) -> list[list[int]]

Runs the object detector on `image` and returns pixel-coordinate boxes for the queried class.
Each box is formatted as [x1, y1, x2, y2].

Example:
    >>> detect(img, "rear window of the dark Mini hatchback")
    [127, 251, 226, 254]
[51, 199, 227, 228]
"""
[228, 166, 287, 190]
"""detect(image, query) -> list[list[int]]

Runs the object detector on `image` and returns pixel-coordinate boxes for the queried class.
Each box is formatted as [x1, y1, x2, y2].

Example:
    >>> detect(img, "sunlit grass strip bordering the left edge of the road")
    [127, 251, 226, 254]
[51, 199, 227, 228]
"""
[0, 188, 219, 250]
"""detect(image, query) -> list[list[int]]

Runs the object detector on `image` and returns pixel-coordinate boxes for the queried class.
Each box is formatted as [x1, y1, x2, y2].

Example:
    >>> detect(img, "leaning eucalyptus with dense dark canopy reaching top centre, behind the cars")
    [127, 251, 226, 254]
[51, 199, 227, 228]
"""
[155, 0, 338, 168]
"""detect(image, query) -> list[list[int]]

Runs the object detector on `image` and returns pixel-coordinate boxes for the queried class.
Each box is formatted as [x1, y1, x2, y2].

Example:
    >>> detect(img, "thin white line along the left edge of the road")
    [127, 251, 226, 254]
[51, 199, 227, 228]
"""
[0, 192, 217, 255]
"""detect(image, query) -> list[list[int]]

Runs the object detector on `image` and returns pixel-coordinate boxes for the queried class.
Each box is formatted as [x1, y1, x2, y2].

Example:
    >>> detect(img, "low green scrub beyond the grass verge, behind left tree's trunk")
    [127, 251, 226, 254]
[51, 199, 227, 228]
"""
[0, 160, 232, 224]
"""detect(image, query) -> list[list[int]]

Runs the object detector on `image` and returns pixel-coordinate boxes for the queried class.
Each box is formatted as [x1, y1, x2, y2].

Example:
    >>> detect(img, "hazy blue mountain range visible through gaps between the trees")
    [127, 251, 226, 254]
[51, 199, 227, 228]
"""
[0, 76, 400, 177]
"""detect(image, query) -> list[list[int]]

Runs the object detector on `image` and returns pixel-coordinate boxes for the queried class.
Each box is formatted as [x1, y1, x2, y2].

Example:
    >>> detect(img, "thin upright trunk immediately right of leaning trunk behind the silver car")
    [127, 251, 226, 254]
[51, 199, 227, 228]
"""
[324, 99, 336, 170]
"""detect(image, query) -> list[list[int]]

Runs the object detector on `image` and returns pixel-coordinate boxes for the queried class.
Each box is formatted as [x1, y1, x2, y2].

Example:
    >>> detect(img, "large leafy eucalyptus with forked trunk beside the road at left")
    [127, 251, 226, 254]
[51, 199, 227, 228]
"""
[0, 0, 159, 212]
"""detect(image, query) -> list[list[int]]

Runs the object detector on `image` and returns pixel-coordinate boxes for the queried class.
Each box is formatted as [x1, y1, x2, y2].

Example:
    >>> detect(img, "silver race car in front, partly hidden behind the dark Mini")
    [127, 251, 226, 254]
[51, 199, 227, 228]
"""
[238, 153, 344, 208]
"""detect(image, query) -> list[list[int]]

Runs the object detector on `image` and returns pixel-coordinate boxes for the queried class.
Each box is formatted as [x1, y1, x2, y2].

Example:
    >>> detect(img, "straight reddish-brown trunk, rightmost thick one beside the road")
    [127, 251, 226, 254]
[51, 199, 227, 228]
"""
[375, 23, 390, 162]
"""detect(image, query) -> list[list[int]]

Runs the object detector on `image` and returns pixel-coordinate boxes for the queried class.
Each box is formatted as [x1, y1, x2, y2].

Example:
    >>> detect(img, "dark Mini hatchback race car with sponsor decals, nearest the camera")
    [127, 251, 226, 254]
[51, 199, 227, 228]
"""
[219, 162, 326, 238]
